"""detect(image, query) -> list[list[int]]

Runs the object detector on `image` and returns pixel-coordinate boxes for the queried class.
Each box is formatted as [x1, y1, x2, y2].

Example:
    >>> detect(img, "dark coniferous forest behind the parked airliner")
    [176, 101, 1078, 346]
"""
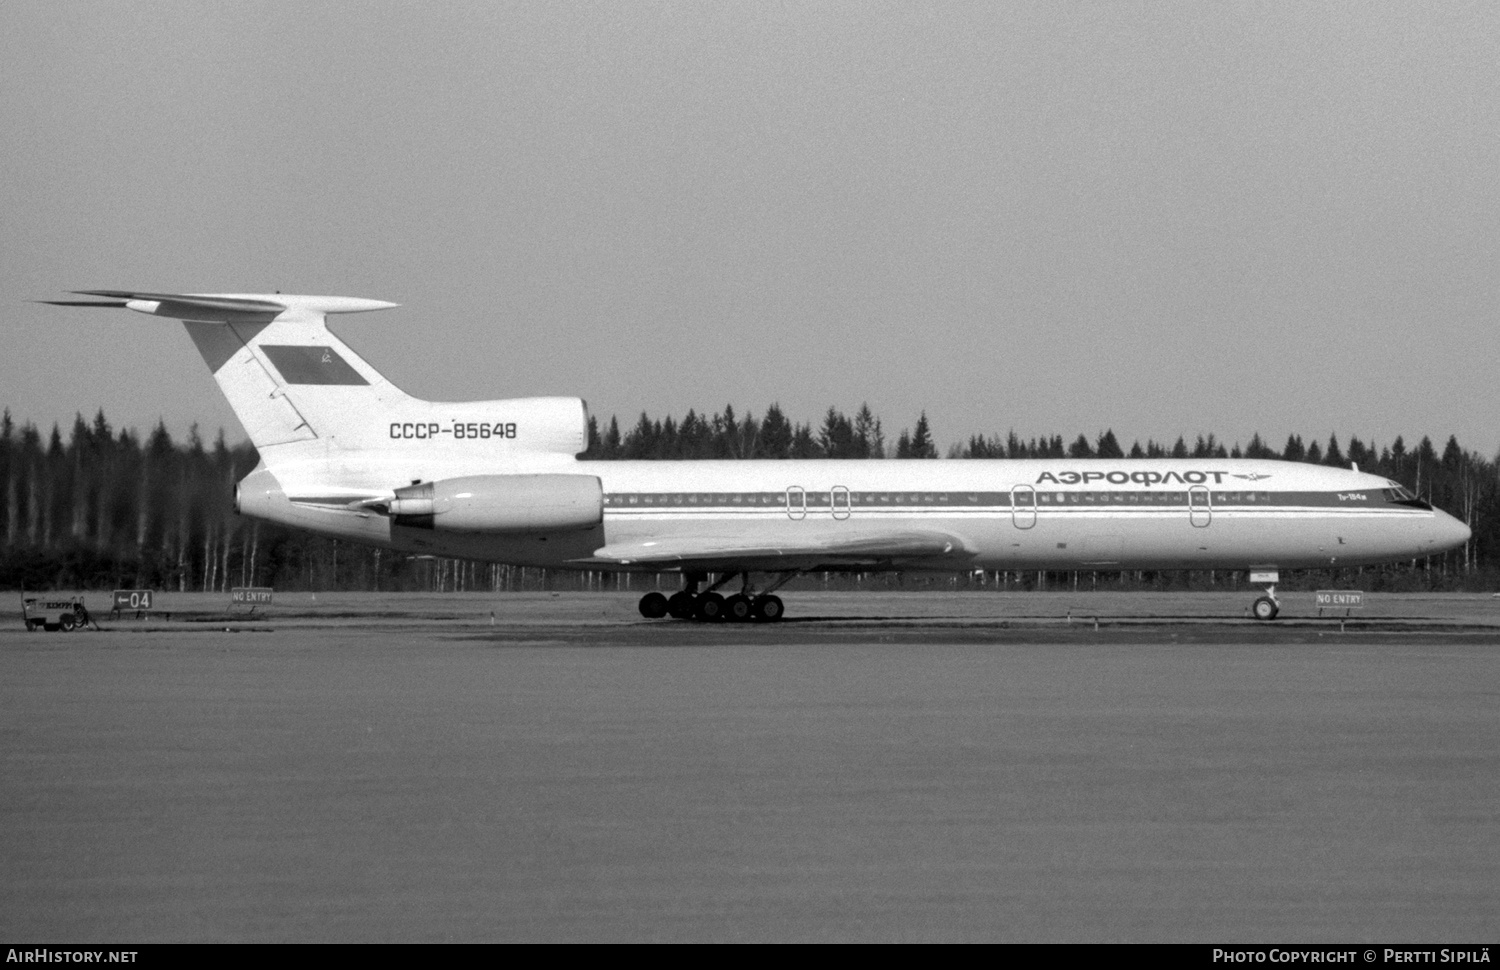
[0, 405, 1500, 592]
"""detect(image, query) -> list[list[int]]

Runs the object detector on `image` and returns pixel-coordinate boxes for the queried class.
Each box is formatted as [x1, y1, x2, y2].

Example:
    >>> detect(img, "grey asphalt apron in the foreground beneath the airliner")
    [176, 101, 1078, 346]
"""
[0, 591, 1500, 943]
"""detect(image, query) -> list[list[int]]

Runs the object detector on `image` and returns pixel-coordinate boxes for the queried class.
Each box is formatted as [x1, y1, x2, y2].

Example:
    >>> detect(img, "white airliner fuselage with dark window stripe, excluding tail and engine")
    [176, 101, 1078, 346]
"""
[242, 453, 1469, 571]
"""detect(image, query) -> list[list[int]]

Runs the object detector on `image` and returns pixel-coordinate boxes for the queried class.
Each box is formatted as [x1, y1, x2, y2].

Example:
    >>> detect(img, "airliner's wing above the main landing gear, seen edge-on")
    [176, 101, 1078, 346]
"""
[572, 531, 974, 573]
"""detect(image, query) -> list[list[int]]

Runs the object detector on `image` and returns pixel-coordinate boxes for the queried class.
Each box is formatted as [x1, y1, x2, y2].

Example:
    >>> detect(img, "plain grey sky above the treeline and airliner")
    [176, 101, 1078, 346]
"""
[0, 0, 1500, 454]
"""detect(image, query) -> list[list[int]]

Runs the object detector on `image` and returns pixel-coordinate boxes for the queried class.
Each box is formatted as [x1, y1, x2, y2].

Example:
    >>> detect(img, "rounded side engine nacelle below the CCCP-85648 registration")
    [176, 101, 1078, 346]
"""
[386, 475, 605, 532]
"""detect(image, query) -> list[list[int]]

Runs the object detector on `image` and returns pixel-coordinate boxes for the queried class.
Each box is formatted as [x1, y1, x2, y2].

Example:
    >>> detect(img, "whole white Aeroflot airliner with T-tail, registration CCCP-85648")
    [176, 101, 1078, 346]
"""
[45, 289, 1470, 622]
